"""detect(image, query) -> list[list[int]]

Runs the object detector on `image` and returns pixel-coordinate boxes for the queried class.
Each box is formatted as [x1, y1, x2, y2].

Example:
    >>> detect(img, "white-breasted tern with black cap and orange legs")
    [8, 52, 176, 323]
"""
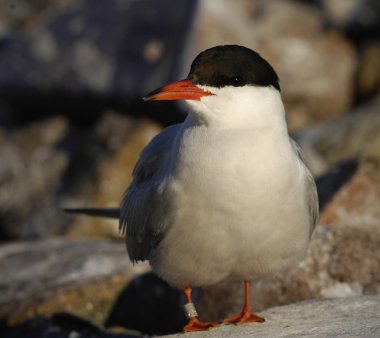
[65, 45, 319, 332]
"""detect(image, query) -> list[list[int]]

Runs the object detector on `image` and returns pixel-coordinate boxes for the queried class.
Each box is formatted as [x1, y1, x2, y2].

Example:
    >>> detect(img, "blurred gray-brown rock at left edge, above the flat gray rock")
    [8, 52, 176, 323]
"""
[0, 117, 68, 240]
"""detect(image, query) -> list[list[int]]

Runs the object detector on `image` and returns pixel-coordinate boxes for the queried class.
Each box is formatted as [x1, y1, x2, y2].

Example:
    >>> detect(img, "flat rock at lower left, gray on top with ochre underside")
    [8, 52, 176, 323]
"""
[0, 238, 147, 325]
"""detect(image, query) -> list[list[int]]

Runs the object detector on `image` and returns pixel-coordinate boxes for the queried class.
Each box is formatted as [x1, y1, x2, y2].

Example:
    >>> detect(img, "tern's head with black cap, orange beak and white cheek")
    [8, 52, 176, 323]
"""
[144, 45, 281, 127]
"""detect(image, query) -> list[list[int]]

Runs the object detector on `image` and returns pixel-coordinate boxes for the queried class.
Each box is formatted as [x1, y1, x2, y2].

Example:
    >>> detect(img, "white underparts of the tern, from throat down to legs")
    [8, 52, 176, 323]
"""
[151, 85, 309, 287]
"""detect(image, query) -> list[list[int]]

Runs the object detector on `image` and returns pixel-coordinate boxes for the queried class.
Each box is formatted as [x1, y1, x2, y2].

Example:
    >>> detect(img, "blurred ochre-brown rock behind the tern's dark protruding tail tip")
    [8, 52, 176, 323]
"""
[64, 113, 161, 238]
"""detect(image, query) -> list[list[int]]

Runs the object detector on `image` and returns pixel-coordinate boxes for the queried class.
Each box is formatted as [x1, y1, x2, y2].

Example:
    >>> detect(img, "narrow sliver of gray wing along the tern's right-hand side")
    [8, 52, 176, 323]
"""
[290, 138, 319, 236]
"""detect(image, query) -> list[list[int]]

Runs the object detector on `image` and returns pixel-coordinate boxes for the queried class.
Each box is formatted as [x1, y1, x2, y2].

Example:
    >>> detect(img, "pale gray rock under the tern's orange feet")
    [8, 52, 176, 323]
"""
[162, 296, 380, 338]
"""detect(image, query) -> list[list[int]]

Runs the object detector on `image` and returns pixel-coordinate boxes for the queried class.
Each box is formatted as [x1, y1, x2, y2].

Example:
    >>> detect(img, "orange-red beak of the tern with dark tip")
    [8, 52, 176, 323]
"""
[143, 80, 215, 101]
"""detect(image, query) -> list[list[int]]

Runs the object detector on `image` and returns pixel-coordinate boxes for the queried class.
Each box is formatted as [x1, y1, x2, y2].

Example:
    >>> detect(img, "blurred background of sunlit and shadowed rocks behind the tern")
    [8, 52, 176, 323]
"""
[0, 0, 380, 337]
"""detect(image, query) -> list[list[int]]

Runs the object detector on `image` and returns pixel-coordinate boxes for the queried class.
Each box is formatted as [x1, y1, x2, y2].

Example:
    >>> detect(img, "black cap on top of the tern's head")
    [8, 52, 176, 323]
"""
[188, 45, 280, 90]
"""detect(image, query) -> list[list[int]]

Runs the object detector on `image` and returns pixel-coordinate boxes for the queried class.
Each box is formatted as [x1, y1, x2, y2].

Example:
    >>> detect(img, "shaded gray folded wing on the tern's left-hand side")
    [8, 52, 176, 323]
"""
[119, 124, 179, 262]
